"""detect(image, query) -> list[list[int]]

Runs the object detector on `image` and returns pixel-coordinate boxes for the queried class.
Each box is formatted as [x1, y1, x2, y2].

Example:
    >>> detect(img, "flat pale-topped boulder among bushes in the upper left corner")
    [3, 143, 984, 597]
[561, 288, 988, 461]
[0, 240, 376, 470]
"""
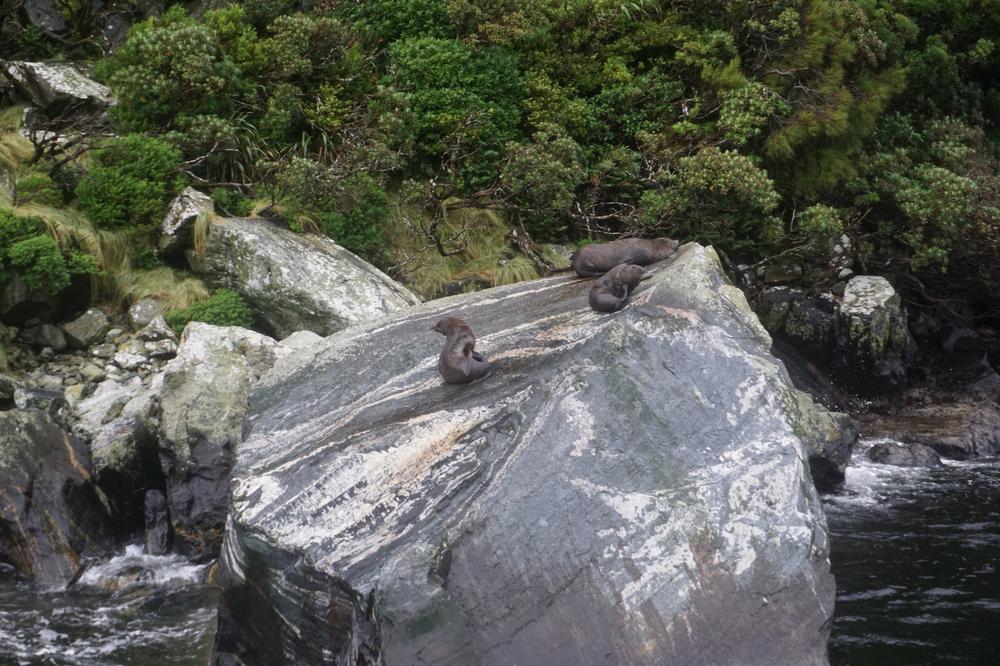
[0, 60, 114, 114]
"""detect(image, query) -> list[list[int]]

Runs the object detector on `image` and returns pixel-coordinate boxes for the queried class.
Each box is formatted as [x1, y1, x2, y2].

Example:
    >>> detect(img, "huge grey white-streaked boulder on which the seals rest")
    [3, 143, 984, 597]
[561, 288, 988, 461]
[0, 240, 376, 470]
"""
[217, 244, 834, 666]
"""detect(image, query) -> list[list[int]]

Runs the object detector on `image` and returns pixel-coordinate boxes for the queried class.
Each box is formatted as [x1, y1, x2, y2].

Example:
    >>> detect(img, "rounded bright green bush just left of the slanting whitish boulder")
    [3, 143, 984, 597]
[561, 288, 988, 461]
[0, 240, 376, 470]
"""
[76, 134, 184, 229]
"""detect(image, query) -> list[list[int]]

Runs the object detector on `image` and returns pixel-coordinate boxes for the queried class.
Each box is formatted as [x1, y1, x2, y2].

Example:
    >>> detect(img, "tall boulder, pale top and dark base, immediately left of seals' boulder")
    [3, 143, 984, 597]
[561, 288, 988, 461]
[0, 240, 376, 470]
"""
[160, 322, 281, 555]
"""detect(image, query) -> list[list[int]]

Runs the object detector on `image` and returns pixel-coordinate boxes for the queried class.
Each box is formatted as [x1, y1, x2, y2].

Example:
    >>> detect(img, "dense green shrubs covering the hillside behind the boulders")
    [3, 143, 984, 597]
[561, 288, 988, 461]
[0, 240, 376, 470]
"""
[1, 0, 1000, 299]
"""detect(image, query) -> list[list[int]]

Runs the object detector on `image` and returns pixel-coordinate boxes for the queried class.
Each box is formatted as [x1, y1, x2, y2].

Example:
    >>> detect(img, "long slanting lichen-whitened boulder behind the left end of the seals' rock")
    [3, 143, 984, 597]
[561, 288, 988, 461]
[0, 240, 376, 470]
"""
[190, 218, 420, 339]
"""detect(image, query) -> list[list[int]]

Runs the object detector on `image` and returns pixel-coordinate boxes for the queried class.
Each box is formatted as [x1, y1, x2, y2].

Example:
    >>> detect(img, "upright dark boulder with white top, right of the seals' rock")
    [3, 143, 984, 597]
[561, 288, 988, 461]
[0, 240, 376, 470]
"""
[831, 275, 914, 397]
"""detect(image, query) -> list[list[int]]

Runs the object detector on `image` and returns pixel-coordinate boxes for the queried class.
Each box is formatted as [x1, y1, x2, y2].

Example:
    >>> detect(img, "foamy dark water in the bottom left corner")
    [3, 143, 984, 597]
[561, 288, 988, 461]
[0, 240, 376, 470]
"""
[0, 546, 218, 666]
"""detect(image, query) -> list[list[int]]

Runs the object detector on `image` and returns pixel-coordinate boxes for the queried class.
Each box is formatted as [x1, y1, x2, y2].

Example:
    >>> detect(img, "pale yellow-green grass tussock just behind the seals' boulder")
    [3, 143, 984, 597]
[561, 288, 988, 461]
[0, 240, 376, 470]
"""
[385, 202, 538, 298]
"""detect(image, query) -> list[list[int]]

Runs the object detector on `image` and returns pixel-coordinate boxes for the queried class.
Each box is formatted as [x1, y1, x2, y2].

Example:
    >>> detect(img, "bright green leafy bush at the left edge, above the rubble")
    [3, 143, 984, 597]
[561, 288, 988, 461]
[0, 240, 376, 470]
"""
[0, 210, 99, 294]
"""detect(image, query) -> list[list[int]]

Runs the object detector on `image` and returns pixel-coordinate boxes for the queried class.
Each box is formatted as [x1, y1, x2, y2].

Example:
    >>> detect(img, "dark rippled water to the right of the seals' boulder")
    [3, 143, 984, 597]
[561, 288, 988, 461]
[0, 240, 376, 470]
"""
[824, 442, 1000, 666]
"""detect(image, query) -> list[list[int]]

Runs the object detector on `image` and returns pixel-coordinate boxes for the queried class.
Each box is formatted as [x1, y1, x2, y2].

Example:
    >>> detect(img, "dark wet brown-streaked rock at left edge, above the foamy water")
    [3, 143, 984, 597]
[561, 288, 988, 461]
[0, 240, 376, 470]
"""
[0, 409, 110, 586]
